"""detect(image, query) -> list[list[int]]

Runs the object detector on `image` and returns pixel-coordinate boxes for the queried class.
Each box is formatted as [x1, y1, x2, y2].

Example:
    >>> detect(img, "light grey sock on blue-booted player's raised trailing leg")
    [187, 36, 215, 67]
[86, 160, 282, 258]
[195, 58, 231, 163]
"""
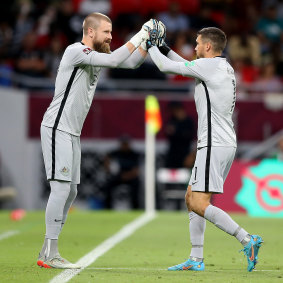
[204, 204, 250, 245]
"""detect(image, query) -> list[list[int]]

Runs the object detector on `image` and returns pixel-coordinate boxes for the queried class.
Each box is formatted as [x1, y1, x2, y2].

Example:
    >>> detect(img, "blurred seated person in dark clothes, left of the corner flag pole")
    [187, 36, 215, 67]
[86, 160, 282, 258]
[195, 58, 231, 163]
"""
[102, 135, 140, 209]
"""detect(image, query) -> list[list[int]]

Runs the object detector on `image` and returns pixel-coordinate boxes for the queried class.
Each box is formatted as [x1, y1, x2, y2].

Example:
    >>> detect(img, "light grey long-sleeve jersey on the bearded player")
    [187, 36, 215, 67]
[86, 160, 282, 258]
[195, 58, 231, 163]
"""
[42, 42, 144, 136]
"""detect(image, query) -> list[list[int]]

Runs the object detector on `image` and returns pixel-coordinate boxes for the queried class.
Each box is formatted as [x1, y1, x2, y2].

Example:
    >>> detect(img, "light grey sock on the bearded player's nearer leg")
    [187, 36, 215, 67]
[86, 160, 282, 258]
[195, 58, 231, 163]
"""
[45, 181, 70, 239]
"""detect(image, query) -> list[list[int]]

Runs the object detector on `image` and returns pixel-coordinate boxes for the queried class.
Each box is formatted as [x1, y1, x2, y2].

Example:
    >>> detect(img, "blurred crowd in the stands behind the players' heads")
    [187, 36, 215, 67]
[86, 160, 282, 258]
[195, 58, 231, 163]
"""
[0, 0, 283, 97]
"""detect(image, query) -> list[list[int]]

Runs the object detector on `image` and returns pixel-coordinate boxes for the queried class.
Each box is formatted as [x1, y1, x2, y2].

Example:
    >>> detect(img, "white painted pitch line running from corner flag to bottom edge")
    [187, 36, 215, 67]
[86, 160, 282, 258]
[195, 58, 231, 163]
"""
[50, 213, 156, 283]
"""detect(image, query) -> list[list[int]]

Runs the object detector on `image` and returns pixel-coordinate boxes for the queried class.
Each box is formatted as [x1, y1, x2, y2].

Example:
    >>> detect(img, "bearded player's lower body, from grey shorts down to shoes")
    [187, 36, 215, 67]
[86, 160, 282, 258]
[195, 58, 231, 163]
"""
[37, 127, 80, 268]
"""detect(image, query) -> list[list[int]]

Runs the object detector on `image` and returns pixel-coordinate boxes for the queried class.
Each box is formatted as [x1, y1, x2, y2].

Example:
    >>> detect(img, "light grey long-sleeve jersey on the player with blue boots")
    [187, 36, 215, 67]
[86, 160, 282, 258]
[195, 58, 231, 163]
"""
[149, 47, 237, 148]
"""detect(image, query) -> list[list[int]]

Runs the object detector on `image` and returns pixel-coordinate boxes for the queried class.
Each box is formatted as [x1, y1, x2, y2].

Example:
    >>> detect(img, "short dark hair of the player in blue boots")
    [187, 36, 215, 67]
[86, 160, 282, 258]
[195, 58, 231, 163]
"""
[197, 27, 227, 52]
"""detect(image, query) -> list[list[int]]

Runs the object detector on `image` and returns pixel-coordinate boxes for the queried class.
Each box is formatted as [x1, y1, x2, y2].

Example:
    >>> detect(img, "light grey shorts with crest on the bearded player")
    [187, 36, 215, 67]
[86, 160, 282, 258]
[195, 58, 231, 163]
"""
[40, 126, 81, 184]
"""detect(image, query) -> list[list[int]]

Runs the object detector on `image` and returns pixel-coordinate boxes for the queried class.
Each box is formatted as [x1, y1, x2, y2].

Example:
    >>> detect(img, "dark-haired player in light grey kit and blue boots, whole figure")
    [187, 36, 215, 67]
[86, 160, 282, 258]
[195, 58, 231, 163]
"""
[146, 22, 263, 271]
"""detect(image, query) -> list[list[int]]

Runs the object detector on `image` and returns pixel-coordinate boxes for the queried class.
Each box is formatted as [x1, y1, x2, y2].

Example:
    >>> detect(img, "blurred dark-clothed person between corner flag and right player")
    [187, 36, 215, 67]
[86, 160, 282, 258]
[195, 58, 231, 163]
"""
[165, 101, 195, 168]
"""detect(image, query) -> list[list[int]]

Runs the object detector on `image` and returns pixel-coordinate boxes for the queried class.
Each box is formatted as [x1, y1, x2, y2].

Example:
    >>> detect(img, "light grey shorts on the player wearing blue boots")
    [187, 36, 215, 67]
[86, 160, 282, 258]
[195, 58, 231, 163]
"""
[189, 146, 236, 194]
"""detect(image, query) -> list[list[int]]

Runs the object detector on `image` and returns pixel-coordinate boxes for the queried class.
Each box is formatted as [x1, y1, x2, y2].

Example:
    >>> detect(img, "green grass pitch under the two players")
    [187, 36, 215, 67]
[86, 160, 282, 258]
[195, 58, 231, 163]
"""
[0, 210, 283, 283]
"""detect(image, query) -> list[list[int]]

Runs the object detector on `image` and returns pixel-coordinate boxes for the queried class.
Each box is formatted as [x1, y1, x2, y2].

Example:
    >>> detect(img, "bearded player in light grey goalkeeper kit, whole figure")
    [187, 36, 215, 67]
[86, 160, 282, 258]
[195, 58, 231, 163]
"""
[37, 13, 156, 268]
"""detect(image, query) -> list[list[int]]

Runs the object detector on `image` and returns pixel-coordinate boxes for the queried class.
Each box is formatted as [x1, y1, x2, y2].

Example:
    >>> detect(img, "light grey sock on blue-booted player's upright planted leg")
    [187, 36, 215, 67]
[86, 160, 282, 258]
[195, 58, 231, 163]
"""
[189, 211, 206, 261]
